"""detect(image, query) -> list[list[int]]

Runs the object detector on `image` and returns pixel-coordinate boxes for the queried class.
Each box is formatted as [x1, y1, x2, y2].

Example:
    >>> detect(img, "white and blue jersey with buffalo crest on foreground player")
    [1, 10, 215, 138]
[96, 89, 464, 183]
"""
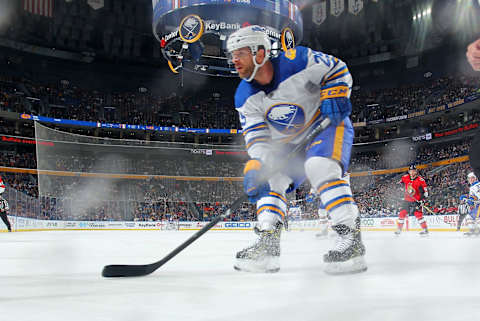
[235, 46, 352, 162]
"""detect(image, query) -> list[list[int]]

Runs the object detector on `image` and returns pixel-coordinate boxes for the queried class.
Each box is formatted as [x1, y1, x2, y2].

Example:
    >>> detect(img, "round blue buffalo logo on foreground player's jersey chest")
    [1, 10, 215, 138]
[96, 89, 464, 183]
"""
[266, 104, 305, 135]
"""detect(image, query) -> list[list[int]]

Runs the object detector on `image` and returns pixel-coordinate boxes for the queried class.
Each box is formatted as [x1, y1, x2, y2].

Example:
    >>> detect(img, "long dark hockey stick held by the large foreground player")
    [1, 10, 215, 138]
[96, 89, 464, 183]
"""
[102, 118, 331, 278]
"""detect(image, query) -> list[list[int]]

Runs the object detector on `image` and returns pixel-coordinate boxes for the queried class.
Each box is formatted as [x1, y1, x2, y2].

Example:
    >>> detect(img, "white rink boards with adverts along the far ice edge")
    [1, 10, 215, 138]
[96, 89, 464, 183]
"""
[0, 214, 471, 232]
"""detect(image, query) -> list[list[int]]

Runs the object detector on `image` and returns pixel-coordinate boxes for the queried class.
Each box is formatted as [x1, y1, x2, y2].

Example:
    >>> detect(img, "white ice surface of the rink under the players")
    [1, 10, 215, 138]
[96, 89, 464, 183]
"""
[0, 231, 480, 321]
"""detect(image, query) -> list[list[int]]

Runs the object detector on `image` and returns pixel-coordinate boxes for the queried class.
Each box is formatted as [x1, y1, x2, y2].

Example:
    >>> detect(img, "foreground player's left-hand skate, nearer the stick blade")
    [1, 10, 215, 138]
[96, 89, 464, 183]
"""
[233, 223, 282, 273]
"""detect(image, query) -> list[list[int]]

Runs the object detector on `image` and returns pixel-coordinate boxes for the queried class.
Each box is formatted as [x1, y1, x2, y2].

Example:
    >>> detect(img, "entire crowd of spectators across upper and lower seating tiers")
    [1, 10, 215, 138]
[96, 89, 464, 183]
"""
[0, 71, 480, 221]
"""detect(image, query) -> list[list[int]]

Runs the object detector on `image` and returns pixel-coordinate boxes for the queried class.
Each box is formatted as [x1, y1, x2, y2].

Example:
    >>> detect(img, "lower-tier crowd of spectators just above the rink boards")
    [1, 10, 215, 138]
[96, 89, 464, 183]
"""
[0, 139, 471, 221]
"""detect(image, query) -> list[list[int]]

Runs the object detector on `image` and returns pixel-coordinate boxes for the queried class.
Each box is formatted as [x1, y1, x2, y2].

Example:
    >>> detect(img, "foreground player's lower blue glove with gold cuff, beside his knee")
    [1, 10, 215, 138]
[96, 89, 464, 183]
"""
[243, 159, 270, 203]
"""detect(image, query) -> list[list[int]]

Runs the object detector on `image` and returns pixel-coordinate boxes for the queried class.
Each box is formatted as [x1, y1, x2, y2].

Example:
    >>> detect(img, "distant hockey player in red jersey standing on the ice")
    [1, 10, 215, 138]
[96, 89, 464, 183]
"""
[395, 165, 428, 236]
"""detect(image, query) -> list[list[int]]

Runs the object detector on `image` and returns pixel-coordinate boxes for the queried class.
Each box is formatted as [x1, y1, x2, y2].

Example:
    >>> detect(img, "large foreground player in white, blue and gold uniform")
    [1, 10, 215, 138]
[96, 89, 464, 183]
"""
[227, 26, 367, 273]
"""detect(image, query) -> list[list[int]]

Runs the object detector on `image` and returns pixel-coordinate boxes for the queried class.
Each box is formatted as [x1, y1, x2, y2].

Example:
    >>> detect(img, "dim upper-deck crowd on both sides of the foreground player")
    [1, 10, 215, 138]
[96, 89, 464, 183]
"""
[0, 76, 479, 131]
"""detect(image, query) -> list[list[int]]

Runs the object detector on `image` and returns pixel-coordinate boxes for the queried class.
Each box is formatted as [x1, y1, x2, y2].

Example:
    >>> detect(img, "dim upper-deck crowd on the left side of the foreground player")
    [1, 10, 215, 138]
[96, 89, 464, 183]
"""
[0, 76, 239, 129]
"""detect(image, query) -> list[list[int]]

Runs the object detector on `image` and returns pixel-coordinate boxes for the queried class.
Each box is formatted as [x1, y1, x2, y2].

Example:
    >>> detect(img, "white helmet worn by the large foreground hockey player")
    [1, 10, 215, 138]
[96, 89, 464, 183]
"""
[227, 25, 272, 81]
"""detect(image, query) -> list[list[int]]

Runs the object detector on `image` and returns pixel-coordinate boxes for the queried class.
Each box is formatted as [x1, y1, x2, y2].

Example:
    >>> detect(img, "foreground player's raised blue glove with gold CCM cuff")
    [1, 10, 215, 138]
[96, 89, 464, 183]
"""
[320, 83, 352, 126]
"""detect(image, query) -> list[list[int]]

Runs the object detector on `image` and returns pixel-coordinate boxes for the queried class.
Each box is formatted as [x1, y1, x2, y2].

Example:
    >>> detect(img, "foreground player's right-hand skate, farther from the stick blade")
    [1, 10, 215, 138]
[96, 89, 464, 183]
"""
[323, 218, 367, 274]
